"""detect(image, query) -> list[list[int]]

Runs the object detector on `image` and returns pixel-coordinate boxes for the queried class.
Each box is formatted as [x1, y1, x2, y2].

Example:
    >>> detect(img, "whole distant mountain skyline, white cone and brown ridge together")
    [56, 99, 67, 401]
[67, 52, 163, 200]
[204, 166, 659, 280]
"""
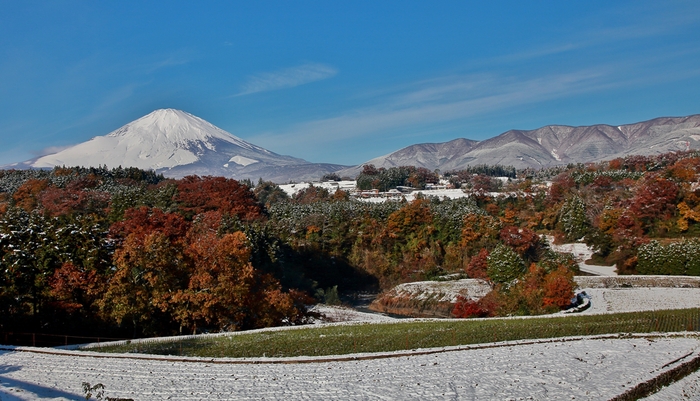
[2, 109, 700, 183]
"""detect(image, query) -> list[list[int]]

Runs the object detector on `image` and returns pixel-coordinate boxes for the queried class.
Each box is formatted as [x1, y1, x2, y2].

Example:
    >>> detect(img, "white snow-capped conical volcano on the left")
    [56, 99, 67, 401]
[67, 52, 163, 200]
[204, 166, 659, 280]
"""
[14, 109, 347, 183]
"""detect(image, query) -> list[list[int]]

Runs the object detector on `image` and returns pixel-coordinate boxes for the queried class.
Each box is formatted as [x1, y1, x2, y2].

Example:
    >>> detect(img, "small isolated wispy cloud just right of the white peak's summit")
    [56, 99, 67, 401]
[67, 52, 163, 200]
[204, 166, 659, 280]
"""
[234, 63, 338, 96]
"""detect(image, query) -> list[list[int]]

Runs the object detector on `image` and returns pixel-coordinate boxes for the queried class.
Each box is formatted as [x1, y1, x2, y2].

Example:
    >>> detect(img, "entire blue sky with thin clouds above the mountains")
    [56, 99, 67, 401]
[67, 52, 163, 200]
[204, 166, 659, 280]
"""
[0, 0, 700, 165]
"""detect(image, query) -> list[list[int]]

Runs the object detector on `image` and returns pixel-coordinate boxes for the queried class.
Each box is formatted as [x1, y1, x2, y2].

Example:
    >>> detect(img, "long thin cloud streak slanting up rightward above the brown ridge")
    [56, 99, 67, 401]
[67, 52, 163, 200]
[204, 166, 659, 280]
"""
[252, 70, 610, 147]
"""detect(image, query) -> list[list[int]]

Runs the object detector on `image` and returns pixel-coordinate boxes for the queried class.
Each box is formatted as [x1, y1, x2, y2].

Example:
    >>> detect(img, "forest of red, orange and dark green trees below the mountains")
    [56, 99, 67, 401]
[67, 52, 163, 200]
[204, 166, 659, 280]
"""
[0, 152, 700, 336]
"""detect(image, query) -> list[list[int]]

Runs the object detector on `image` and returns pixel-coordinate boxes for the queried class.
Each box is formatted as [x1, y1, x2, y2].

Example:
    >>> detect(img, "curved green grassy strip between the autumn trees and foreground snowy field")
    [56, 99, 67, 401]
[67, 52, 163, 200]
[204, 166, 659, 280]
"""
[91, 309, 700, 358]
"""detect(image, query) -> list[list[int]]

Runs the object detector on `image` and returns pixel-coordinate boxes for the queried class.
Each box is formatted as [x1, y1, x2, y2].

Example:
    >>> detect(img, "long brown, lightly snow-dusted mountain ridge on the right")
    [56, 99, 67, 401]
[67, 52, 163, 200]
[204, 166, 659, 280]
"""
[338, 115, 700, 176]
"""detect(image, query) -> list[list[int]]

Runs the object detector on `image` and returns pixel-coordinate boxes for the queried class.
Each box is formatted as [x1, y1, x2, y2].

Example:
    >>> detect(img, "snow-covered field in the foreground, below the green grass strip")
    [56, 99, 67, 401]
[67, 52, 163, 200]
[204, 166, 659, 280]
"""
[0, 337, 700, 401]
